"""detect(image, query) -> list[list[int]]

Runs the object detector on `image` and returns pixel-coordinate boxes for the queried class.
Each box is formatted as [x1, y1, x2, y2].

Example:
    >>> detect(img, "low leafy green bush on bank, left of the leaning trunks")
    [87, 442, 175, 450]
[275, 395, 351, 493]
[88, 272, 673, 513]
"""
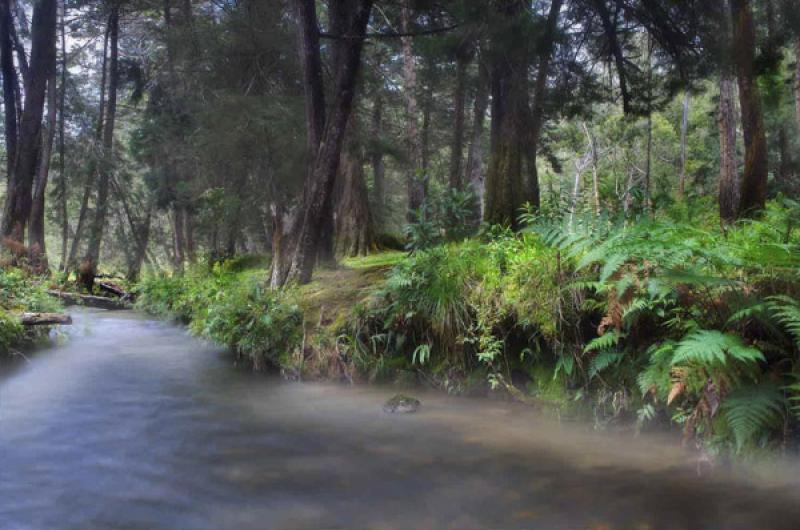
[136, 262, 302, 370]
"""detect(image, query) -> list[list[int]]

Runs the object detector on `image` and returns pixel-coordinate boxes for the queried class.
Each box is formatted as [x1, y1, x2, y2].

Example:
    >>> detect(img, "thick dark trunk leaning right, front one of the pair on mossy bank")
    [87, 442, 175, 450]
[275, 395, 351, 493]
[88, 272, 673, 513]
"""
[287, 0, 372, 284]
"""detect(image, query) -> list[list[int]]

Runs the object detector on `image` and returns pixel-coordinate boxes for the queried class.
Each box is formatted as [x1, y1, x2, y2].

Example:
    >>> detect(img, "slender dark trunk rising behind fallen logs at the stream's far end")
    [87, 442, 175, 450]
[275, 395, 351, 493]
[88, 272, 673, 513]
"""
[82, 3, 119, 287]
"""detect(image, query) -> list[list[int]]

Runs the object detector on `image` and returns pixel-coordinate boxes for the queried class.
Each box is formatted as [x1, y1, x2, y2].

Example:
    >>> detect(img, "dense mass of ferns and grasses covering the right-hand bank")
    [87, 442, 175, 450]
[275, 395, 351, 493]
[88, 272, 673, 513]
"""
[356, 201, 800, 451]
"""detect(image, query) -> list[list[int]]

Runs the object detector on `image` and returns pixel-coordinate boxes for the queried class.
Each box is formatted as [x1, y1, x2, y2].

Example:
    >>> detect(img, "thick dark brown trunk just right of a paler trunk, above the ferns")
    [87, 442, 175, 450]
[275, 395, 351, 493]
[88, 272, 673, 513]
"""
[730, 0, 768, 217]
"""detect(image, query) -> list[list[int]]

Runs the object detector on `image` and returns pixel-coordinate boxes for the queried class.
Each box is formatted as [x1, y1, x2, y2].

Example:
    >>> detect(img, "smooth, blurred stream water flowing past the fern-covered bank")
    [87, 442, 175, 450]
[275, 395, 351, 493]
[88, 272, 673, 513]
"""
[0, 311, 800, 530]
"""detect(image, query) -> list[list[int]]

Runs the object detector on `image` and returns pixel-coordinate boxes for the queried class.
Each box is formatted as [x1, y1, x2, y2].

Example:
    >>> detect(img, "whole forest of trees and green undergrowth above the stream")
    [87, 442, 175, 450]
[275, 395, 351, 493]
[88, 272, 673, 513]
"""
[0, 0, 800, 453]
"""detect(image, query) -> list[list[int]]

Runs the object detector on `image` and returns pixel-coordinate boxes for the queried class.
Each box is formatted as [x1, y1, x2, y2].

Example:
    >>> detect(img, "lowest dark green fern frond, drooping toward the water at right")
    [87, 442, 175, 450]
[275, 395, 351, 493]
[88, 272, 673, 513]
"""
[720, 385, 785, 451]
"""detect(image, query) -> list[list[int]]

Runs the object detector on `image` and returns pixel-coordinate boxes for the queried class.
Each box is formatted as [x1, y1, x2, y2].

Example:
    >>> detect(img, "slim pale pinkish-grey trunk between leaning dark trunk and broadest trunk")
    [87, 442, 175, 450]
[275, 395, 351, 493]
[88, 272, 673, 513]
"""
[400, 0, 425, 216]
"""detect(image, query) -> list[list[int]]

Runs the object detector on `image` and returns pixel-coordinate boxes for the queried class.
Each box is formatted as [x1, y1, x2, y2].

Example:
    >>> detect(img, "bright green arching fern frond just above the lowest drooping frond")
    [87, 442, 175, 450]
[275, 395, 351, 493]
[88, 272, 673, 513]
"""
[672, 329, 765, 366]
